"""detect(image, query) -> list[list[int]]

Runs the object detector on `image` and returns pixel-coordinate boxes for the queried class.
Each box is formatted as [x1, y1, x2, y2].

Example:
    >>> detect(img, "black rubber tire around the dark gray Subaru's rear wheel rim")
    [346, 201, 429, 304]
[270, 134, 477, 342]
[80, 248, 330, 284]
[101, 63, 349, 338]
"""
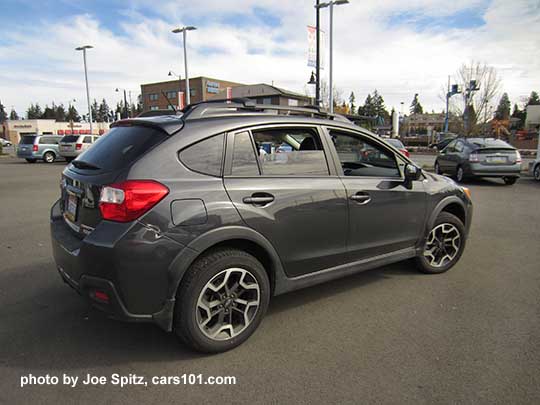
[173, 249, 270, 353]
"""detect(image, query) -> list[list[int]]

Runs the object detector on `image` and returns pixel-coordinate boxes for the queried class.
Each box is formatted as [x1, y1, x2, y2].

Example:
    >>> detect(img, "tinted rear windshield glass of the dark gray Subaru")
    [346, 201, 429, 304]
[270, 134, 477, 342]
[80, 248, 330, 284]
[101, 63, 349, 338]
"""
[76, 127, 167, 171]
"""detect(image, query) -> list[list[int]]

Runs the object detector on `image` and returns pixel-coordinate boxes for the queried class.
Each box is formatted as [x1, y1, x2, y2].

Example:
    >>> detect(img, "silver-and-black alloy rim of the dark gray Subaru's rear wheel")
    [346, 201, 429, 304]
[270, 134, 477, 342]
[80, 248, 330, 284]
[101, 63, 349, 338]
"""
[196, 268, 261, 340]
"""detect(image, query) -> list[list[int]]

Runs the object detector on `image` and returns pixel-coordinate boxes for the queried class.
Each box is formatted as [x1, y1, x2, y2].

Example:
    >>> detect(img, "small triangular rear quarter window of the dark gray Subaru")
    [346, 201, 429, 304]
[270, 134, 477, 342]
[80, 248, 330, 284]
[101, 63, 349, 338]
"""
[178, 134, 225, 176]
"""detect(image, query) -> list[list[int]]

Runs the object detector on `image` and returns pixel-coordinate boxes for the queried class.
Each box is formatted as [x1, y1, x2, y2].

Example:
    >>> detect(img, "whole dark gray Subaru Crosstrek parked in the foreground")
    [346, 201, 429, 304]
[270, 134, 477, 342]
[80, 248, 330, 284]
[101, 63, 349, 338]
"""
[51, 100, 472, 352]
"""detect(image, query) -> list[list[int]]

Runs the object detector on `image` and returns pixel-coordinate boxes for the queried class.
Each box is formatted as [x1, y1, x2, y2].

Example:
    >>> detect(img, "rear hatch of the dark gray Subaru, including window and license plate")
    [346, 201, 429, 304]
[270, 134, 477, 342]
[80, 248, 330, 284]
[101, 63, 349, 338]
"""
[60, 126, 168, 238]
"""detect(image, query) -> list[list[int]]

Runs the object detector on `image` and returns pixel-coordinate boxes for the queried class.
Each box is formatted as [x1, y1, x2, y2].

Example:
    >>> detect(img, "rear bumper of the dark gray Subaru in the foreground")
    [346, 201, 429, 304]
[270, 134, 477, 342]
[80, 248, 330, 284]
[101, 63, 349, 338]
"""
[50, 200, 182, 330]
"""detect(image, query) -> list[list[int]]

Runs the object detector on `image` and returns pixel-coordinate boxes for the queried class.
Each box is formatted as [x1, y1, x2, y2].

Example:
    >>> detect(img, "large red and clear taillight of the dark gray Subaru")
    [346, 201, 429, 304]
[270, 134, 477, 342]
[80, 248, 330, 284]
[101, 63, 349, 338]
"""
[99, 180, 169, 222]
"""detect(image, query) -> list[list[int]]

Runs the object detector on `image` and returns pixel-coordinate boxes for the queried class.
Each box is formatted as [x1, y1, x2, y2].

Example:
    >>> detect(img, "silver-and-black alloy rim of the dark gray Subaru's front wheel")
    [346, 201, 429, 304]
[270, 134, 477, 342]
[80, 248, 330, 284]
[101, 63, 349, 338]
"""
[424, 223, 461, 267]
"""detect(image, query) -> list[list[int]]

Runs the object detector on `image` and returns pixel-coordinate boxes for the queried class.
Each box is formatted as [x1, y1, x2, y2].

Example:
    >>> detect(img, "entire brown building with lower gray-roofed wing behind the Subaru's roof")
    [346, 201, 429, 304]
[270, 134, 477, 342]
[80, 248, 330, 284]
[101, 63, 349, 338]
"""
[141, 77, 310, 111]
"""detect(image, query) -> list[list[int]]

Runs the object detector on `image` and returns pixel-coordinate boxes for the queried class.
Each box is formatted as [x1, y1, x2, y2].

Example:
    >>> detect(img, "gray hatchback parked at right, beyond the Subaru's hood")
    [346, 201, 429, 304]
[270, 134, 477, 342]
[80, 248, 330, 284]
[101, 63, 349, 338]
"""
[435, 138, 521, 184]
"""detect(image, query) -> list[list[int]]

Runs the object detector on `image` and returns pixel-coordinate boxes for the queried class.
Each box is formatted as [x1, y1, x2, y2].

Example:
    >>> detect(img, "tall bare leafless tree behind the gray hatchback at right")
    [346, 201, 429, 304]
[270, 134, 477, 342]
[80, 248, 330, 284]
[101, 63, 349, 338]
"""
[448, 61, 501, 132]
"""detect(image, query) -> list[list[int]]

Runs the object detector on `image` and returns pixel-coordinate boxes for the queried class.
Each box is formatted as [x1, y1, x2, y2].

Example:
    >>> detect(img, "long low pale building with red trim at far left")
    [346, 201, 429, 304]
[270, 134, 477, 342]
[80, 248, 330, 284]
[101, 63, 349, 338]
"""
[0, 119, 109, 144]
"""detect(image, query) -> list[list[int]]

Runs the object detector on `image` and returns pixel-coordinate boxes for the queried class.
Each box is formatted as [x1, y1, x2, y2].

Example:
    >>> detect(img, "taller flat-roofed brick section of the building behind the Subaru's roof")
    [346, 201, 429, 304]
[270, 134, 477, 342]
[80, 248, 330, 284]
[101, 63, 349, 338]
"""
[141, 76, 241, 111]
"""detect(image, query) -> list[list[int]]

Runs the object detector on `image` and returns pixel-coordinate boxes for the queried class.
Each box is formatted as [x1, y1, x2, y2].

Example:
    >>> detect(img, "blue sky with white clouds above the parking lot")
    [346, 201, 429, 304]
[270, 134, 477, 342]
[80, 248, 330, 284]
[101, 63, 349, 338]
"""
[0, 0, 540, 114]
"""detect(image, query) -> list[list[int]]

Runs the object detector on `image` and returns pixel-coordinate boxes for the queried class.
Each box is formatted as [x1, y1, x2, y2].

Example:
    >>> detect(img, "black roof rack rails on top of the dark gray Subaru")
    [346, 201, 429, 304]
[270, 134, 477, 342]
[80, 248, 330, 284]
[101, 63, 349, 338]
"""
[182, 98, 351, 122]
